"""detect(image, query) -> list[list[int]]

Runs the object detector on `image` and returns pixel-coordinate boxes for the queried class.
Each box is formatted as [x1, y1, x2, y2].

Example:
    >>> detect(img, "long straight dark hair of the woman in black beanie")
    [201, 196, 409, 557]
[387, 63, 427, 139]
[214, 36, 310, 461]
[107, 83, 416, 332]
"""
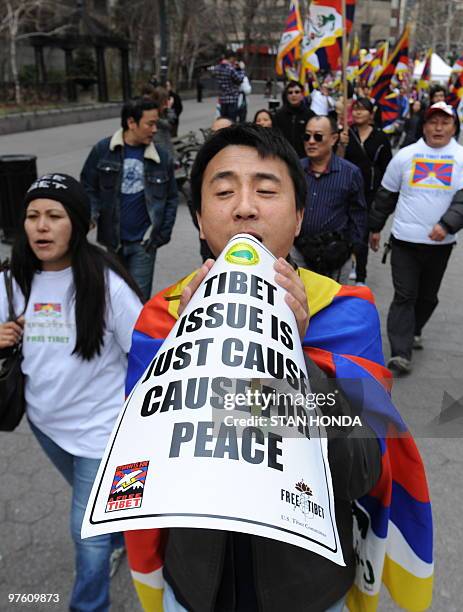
[10, 208, 142, 361]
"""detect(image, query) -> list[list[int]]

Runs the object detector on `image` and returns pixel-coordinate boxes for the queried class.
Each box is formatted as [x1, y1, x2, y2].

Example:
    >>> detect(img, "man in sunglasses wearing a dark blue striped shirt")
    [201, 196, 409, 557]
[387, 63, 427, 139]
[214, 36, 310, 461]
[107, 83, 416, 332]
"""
[291, 116, 367, 284]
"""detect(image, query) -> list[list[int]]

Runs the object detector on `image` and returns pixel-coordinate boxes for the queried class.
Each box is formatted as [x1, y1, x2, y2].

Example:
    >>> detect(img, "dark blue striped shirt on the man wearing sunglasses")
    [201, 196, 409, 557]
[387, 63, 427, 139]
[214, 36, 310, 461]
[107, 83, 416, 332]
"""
[301, 153, 367, 244]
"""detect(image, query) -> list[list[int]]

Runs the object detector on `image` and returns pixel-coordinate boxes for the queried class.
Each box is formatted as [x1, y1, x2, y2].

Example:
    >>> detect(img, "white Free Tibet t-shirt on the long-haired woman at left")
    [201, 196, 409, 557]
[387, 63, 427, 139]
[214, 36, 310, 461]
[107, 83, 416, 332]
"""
[0, 268, 142, 459]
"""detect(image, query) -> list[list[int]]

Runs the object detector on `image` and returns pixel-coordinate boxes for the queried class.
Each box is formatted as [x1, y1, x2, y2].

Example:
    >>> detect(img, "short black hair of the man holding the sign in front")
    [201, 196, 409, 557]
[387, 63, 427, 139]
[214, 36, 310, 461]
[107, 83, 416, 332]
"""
[190, 123, 306, 212]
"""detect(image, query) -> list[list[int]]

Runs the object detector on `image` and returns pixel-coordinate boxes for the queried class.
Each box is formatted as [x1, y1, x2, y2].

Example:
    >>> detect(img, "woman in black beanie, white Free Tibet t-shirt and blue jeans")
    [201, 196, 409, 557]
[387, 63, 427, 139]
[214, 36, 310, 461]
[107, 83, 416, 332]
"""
[0, 174, 142, 611]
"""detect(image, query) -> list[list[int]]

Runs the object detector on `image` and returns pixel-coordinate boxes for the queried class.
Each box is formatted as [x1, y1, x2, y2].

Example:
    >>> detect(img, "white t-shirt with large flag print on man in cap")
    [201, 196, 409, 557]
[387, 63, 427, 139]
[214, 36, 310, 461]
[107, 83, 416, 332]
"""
[382, 138, 463, 245]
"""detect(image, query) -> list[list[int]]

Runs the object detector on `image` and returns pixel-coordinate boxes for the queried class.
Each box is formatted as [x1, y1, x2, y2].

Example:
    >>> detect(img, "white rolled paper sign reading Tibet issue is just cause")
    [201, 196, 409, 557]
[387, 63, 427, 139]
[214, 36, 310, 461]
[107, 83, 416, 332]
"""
[82, 234, 344, 565]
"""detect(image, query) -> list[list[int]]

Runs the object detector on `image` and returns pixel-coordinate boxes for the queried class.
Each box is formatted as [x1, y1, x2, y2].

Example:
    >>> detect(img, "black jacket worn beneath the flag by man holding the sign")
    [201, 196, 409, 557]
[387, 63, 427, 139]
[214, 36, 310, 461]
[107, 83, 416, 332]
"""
[164, 360, 381, 612]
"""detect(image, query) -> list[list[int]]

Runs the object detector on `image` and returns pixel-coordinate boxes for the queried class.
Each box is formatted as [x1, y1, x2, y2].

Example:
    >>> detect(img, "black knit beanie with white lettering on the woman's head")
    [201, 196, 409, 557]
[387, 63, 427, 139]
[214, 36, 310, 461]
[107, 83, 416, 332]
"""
[24, 174, 90, 234]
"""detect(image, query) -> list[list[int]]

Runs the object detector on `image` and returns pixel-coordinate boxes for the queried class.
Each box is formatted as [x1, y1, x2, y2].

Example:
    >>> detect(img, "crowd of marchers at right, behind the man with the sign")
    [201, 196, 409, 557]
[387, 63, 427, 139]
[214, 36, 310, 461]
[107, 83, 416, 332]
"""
[239, 80, 463, 375]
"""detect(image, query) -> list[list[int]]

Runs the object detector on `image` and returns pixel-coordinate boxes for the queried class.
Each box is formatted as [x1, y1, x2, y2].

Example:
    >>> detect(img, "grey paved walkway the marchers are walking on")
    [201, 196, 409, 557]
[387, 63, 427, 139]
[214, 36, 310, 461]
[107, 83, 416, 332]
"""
[0, 103, 463, 612]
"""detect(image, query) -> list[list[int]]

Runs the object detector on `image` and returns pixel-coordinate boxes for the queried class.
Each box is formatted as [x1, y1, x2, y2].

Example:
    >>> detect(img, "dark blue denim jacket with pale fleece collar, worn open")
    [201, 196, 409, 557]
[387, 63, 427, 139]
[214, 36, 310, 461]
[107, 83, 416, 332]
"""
[80, 129, 178, 250]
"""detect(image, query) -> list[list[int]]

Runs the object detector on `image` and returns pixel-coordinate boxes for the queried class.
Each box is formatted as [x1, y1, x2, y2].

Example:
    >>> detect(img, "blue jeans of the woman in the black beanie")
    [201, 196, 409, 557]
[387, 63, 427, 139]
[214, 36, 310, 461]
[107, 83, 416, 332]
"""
[29, 421, 123, 612]
